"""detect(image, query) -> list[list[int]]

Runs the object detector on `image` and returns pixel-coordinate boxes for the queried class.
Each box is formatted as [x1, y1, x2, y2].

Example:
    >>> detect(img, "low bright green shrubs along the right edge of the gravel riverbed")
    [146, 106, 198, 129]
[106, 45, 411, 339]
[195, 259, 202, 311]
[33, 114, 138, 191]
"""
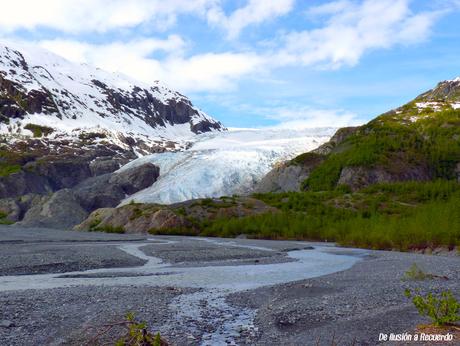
[192, 181, 460, 251]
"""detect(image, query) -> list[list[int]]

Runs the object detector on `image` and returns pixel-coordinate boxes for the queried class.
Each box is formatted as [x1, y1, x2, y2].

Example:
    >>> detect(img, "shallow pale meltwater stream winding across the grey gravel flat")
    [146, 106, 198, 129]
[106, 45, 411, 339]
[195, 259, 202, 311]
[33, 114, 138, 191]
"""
[0, 238, 366, 345]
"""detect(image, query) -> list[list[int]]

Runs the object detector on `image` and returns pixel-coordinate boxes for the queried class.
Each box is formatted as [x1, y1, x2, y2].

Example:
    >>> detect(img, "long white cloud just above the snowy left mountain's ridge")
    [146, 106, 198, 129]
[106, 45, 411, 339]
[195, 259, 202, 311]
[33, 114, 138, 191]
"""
[40, 35, 263, 92]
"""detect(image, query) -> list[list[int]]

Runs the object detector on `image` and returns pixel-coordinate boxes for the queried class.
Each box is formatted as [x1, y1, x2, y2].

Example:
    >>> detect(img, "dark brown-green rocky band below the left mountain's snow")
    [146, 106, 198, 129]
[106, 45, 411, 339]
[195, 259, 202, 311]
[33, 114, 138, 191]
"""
[0, 139, 136, 199]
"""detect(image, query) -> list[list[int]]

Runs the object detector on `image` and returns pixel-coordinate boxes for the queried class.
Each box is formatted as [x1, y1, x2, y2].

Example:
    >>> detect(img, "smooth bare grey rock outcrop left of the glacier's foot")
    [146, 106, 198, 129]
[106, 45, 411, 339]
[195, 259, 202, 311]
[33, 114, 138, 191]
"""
[0, 163, 159, 229]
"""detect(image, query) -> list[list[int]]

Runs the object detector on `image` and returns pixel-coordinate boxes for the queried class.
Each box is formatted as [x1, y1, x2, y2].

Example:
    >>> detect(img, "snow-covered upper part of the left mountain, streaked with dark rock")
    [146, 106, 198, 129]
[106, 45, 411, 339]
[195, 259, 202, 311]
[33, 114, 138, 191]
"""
[0, 43, 225, 154]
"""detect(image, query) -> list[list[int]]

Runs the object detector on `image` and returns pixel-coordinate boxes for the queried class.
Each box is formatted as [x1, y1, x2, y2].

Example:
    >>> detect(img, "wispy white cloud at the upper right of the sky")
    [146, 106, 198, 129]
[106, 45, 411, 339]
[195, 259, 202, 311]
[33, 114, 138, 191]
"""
[273, 0, 439, 68]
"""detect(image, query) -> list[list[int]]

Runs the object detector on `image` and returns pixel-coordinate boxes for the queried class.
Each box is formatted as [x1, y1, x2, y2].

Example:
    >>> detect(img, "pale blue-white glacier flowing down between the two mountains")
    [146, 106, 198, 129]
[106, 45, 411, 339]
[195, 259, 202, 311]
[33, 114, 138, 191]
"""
[120, 128, 336, 205]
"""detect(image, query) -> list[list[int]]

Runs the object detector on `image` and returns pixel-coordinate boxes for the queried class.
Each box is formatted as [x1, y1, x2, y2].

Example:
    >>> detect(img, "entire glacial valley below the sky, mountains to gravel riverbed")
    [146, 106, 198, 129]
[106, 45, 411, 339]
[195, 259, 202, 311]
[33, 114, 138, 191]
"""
[0, 43, 460, 346]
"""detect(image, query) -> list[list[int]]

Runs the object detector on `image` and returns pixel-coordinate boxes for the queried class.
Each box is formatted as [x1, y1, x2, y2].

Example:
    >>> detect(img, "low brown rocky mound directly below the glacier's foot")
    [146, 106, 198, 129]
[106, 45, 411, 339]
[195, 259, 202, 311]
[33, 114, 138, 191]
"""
[74, 197, 277, 234]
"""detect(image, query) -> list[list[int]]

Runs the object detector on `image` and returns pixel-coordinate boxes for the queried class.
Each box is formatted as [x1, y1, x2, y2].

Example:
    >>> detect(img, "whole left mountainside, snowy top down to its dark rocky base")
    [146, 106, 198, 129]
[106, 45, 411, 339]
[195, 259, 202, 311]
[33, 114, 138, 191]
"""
[0, 43, 225, 207]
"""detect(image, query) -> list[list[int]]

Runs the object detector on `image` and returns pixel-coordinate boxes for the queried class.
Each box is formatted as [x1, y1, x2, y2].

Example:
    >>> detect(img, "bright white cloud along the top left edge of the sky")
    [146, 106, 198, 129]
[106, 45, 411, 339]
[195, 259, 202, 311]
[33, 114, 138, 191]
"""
[0, 0, 218, 33]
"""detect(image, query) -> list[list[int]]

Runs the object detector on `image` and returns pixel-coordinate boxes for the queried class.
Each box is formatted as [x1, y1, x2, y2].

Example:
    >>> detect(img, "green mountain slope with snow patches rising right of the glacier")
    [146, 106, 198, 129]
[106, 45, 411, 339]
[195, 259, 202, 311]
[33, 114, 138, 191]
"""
[263, 78, 460, 192]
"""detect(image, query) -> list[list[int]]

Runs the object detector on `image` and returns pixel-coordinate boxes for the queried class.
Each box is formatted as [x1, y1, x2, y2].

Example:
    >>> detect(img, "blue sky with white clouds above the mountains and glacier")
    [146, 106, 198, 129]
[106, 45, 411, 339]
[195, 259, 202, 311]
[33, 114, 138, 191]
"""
[0, 0, 460, 128]
